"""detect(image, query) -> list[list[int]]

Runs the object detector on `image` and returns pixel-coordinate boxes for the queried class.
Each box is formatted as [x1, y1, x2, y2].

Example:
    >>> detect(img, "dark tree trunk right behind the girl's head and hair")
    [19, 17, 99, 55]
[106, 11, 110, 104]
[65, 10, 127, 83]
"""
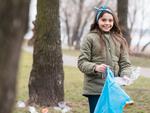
[117, 0, 131, 46]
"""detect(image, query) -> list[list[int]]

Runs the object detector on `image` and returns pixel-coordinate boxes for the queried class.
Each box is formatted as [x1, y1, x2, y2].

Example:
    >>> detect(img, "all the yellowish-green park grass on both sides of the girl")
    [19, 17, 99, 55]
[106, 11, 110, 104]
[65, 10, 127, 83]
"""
[13, 50, 150, 113]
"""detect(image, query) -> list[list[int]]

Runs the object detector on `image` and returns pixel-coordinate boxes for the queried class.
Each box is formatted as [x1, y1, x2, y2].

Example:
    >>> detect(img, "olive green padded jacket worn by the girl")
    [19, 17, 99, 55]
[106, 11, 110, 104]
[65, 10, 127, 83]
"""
[78, 31, 131, 95]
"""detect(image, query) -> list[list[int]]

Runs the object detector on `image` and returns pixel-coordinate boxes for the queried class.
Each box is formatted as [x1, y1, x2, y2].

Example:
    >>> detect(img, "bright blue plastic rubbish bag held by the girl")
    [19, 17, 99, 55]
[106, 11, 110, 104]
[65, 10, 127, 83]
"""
[94, 67, 131, 113]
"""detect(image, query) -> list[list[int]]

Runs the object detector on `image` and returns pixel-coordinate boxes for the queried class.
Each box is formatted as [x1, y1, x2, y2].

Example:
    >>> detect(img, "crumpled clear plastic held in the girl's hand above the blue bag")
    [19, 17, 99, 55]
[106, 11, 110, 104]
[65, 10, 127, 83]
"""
[115, 67, 141, 85]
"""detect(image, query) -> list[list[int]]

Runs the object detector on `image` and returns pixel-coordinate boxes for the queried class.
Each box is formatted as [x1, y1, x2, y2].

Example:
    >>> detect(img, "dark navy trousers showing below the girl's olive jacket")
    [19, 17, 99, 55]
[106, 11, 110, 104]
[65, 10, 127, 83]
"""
[87, 95, 99, 113]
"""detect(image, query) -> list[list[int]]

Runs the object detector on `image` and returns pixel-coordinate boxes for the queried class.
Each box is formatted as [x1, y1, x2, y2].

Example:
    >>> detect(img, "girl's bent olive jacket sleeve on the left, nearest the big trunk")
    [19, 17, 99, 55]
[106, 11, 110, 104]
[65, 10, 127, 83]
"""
[78, 36, 95, 74]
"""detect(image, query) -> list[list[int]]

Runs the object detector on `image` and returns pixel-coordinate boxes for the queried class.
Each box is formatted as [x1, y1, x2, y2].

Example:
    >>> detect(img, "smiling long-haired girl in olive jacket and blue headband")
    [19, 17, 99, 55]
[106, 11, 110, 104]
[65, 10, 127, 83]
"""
[78, 7, 131, 113]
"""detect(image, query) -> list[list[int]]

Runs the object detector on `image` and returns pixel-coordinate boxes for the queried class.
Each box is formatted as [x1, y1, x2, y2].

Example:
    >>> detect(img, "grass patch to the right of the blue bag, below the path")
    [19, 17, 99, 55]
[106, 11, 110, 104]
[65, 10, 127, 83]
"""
[125, 77, 150, 113]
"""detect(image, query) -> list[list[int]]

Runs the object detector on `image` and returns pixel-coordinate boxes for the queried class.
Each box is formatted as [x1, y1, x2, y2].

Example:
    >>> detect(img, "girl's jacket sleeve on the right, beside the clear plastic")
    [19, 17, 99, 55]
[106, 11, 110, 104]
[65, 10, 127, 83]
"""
[119, 42, 131, 77]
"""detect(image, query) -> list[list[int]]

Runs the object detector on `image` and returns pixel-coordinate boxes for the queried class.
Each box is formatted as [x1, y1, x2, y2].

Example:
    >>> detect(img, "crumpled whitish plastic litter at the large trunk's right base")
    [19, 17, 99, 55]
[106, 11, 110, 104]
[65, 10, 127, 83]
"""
[54, 102, 71, 113]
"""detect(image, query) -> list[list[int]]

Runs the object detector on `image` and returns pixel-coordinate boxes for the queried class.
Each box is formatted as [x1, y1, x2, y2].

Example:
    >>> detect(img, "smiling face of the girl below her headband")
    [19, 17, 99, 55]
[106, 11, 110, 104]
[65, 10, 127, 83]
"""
[98, 13, 114, 32]
